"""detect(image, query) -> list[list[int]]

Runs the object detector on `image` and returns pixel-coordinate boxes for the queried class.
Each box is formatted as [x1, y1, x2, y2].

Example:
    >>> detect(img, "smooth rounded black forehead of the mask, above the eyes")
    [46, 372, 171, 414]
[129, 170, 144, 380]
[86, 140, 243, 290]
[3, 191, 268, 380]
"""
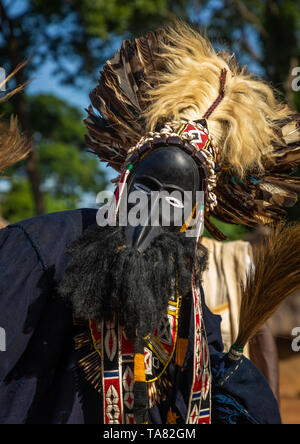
[131, 146, 200, 191]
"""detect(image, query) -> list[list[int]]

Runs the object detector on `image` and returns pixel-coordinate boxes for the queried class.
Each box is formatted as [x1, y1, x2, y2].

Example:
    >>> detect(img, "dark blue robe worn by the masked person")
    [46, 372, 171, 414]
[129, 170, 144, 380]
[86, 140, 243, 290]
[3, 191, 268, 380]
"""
[0, 210, 280, 424]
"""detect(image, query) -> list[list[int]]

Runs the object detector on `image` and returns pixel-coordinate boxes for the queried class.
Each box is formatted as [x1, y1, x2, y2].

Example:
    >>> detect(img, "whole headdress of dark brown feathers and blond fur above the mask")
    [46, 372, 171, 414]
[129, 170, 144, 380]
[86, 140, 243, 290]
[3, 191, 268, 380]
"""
[85, 24, 300, 239]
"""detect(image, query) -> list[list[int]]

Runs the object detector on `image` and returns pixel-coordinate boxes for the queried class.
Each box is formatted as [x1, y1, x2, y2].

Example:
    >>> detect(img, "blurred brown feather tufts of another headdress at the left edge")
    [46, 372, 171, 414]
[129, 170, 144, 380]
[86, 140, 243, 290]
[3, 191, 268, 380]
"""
[0, 62, 32, 171]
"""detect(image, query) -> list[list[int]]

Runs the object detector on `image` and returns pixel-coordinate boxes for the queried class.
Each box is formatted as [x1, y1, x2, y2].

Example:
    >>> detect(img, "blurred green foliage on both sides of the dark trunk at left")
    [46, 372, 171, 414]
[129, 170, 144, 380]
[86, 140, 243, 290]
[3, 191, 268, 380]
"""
[2, 95, 106, 222]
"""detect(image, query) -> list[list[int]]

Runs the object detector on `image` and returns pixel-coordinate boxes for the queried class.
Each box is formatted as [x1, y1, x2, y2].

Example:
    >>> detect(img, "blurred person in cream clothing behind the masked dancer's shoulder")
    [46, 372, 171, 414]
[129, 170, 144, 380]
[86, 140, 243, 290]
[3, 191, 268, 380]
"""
[202, 237, 279, 400]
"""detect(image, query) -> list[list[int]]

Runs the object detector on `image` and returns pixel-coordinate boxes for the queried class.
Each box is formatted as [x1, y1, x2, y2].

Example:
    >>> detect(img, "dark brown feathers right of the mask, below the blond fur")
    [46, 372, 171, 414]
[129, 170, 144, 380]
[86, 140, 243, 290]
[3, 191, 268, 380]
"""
[212, 114, 300, 236]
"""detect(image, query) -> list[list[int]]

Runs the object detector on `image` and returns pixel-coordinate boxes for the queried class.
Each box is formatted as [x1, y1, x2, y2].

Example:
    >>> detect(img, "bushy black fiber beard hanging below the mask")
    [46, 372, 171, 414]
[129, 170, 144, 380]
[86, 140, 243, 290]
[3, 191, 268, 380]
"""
[60, 226, 207, 339]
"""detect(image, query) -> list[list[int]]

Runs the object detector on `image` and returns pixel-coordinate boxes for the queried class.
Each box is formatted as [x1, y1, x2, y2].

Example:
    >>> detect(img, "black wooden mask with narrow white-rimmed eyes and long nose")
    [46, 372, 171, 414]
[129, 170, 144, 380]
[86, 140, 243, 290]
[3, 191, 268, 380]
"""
[125, 145, 202, 251]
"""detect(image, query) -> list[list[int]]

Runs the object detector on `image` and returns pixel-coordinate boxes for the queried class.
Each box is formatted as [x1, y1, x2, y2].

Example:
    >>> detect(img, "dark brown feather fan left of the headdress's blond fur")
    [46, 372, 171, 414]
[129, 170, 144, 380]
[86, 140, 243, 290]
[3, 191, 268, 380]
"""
[85, 31, 166, 171]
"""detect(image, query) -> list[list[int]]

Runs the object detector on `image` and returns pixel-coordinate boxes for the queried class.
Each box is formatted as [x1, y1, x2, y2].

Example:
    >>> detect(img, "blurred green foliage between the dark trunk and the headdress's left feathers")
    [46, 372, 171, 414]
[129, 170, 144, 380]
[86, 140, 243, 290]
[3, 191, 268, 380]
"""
[29, 95, 106, 198]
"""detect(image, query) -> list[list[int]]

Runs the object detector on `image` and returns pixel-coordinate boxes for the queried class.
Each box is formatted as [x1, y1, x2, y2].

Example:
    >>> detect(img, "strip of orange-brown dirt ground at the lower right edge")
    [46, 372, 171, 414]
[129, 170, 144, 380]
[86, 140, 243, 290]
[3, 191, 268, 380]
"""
[277, 341, 300, 424]
